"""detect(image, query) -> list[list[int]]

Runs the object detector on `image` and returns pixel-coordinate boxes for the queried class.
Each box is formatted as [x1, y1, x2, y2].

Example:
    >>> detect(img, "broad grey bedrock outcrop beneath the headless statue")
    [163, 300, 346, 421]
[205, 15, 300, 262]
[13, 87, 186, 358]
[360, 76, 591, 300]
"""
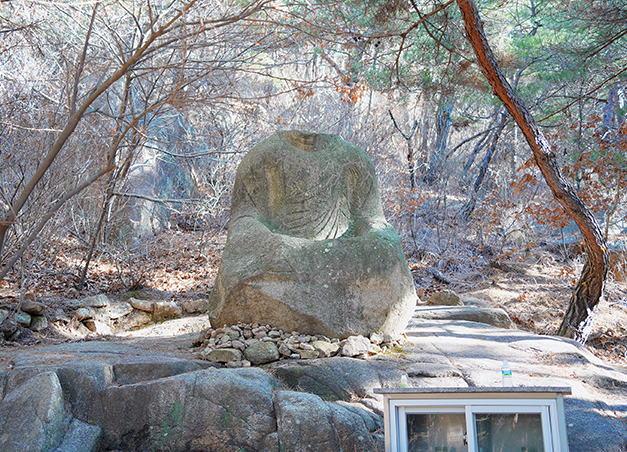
[0, 301, 627, 452]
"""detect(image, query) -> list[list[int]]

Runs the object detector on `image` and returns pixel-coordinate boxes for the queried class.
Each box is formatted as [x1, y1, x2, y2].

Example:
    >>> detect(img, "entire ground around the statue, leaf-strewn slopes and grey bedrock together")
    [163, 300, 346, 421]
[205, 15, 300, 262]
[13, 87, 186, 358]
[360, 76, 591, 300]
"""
[0, 233, 627, 452]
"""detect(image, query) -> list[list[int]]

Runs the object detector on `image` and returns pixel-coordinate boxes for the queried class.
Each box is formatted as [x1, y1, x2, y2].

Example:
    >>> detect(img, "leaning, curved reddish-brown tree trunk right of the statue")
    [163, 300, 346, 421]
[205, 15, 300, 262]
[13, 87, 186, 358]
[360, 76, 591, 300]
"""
[457, 0, 609, 343]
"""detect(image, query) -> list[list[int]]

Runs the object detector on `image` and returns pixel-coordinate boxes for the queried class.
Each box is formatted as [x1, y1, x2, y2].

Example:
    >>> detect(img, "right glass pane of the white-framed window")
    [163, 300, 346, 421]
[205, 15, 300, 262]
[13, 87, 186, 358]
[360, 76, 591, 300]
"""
[475, 413, 544, 452]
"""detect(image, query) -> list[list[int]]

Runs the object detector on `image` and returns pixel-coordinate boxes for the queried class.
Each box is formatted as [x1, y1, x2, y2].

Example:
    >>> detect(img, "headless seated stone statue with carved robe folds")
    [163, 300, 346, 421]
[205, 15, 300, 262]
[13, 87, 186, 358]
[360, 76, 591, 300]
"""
[209, 131, 416, 337]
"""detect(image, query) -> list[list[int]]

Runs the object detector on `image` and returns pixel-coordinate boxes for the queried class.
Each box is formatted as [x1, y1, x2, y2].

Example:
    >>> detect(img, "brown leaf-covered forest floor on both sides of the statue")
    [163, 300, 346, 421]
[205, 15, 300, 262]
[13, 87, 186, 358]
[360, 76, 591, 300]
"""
[0, 231, 627, 366]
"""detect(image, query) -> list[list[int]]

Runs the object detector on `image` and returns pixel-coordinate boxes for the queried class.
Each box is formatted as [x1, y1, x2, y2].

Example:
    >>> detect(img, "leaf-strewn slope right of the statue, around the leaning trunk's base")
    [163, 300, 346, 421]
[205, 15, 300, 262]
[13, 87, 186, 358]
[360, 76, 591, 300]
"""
[412, 247, 627, 365]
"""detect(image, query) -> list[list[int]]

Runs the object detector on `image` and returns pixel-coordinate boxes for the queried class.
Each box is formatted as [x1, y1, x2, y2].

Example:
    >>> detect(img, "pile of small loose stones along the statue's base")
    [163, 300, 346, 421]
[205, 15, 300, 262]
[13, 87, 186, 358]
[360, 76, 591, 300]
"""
[194, 323, 401, 367]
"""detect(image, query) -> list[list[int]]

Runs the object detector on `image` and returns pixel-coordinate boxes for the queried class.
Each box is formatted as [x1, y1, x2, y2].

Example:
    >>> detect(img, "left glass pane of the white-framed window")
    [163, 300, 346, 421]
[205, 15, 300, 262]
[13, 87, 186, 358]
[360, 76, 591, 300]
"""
[407, 413, 468, 452]
